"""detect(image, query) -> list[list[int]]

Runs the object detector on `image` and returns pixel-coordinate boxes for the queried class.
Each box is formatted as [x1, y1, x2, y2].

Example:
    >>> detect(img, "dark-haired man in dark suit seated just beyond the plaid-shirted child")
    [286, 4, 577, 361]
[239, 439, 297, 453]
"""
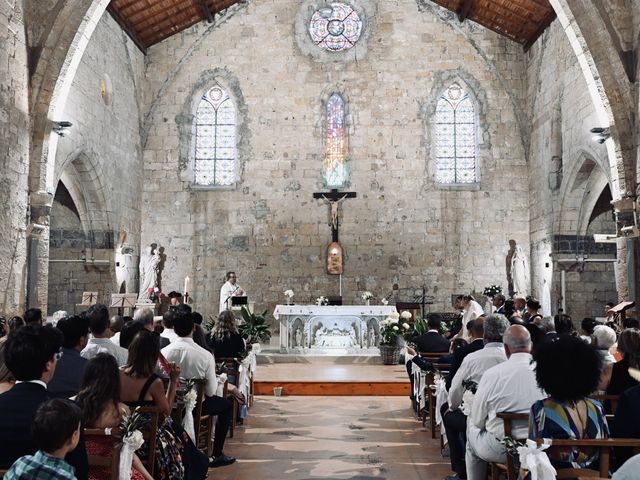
[0, 324, 88, 479]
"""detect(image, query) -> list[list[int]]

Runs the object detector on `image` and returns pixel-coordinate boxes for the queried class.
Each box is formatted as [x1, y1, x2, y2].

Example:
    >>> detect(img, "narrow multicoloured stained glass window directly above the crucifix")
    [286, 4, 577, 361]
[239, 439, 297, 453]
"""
[322, 93, 349, 188]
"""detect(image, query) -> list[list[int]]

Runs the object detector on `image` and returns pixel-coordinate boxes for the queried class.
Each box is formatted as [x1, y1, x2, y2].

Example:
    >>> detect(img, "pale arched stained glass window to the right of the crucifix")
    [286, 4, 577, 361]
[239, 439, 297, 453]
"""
[434, 83, 478, 183]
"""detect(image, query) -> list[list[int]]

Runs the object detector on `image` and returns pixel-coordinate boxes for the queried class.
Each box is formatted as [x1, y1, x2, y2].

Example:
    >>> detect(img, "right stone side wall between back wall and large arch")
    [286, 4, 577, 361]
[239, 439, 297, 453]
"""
[526, 22, 617, 322]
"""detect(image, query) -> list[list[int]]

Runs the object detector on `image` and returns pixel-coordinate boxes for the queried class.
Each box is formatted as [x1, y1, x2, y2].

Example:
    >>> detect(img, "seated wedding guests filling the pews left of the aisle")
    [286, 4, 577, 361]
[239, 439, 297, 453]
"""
[0, 305, 250, 480]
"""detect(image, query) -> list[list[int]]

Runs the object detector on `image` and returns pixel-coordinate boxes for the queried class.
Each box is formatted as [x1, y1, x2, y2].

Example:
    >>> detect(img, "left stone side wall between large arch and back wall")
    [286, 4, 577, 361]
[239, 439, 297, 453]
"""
[48, 14, 144, 313]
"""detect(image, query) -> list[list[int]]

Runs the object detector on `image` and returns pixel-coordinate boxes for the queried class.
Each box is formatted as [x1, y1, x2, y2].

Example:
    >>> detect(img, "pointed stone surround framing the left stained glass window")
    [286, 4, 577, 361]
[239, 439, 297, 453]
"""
[175, 68, 251, 189]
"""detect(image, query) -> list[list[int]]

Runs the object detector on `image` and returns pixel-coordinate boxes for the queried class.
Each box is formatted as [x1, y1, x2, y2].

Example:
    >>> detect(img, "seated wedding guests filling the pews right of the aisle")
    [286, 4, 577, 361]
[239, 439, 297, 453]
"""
[406, 295, 640, 480]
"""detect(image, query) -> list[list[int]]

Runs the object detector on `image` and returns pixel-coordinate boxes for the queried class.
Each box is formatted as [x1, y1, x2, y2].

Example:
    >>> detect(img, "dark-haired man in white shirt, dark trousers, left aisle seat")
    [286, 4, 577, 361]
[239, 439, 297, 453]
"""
[162, 310, 236, 467]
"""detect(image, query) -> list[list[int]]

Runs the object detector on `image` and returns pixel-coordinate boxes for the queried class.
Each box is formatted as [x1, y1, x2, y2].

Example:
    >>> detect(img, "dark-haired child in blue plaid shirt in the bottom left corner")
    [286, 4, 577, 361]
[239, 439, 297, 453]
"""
[3, 398, 81, 480]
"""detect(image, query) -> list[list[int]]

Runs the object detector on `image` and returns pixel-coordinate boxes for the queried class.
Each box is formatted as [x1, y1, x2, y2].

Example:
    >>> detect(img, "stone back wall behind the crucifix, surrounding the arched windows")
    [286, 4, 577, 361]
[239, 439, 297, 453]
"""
[141, 0, 528, 324]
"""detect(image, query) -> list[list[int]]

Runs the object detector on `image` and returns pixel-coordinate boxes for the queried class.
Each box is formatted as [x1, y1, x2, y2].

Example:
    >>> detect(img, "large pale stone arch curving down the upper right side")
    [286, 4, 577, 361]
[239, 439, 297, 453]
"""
[550, 0, 636, 199]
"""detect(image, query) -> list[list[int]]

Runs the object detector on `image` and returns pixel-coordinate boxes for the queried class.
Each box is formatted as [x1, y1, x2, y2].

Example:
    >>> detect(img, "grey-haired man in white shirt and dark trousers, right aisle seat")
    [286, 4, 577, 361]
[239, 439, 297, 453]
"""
[442, 314, 509, 479]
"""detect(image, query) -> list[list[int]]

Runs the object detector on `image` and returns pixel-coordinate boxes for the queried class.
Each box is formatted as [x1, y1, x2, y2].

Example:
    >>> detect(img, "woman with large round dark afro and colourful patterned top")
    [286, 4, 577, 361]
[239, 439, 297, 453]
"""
[529, 336, 609, 468]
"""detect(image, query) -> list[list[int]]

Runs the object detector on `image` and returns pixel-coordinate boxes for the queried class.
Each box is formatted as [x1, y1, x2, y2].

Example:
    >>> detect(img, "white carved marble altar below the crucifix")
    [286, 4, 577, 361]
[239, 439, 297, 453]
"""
[273, 305, 396, 355]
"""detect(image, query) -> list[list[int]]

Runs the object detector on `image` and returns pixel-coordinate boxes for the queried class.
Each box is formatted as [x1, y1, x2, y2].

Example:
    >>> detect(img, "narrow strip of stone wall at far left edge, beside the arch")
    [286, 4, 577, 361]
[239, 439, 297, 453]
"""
[0, 0, 29, 315]
